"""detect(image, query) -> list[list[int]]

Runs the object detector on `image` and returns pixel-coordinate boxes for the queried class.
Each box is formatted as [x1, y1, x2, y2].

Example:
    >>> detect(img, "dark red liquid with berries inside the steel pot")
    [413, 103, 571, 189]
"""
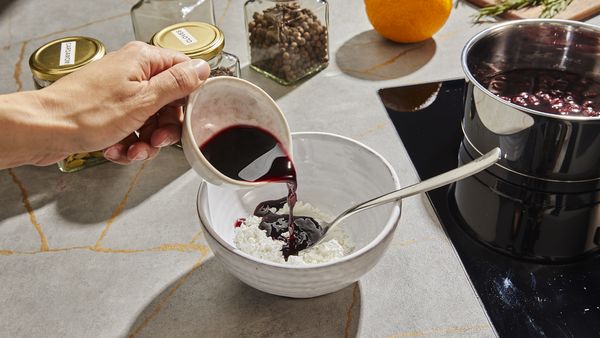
[484, 69, 600, 116]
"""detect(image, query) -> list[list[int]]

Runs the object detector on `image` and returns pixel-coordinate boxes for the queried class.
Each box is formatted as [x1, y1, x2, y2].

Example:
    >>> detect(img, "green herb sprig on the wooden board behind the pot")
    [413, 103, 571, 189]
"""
[475, 0, 573, 22]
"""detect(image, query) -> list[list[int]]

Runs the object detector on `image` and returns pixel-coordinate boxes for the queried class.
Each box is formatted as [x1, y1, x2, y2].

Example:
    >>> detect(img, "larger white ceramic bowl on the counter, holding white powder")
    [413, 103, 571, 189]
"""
[197, 133, 401, 298]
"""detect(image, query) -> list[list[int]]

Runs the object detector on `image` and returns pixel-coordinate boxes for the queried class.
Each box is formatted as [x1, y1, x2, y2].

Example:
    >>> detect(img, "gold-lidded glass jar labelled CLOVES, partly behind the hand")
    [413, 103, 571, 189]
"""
[150, 22, 240, 77]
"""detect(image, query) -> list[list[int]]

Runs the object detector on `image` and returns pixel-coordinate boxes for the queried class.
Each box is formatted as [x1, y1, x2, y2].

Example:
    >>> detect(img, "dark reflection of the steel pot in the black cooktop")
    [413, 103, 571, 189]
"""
[451, 144, 600, 263]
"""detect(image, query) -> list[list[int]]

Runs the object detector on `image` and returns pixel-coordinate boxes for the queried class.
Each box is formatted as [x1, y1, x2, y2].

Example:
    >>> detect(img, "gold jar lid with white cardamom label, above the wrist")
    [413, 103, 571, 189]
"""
[29, 36, 106, 82]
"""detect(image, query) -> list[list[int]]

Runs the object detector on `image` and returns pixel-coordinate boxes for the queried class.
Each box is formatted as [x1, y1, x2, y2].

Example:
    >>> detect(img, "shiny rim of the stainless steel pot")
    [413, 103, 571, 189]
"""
[460, 18, 600, 121]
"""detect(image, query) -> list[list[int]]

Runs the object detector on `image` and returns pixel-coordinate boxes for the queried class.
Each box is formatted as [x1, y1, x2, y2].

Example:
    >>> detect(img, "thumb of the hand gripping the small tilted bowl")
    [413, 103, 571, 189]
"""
[147, 59, 210, 111]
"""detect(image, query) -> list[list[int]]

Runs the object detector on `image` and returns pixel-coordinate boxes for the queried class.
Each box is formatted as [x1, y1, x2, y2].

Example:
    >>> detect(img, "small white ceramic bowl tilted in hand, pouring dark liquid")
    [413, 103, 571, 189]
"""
[181, 76, 292, 186]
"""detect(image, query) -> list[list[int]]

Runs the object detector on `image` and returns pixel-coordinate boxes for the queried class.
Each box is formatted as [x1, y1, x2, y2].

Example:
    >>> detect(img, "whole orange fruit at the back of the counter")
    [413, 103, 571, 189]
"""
[365, 0, 452, 42]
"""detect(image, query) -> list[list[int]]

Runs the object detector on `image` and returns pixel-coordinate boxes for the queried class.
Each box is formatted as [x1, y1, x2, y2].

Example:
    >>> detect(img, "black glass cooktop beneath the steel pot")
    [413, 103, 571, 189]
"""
[379, 79, 600, 337]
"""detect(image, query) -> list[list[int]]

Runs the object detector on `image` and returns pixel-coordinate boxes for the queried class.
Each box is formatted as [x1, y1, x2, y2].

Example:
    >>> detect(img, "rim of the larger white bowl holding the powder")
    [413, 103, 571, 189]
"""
[196, 132, 402, 270]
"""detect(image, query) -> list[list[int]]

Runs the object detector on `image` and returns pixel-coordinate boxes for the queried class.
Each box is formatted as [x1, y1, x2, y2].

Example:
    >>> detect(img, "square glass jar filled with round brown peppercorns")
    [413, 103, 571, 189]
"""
[244, 0, 329, 85]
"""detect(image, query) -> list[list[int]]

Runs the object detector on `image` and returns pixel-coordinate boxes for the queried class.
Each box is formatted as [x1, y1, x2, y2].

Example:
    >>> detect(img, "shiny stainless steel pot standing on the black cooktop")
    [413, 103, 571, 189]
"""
[462, 19, 600, 185]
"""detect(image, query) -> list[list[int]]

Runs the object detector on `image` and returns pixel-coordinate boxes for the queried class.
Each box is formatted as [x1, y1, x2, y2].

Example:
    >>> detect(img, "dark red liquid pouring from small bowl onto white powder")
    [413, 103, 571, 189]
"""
[200, 125, 324, 260]
